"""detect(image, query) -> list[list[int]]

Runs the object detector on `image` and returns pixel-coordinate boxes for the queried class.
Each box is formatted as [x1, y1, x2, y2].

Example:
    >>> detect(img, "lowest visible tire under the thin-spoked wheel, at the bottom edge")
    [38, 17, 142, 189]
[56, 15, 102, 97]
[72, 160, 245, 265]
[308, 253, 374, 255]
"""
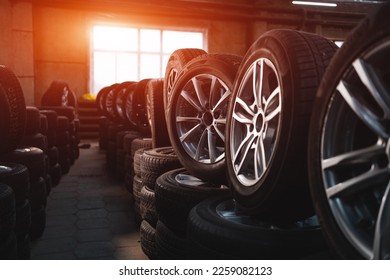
[155, 221, 187, 260]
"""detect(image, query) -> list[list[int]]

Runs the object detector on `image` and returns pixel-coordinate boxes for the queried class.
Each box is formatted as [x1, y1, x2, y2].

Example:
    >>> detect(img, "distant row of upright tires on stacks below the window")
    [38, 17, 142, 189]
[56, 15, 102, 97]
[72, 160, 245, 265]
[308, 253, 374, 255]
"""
[96, 79, 154, 180]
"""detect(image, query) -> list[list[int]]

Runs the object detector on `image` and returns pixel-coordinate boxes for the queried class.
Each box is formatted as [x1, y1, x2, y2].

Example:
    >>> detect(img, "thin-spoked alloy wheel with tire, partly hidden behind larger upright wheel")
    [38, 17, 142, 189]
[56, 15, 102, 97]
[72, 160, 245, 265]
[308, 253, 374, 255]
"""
[167, 54, 241, 182]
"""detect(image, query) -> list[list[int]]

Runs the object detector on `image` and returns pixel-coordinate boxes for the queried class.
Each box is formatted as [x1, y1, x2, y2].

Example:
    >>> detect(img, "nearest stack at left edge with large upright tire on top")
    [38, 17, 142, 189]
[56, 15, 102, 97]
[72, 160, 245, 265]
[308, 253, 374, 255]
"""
[0, 66, 31, 259]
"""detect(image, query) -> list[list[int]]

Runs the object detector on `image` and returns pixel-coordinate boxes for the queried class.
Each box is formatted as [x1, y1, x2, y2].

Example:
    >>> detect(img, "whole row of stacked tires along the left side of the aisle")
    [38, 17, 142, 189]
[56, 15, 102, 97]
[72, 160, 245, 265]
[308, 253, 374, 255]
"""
[0, 66, 82, 259]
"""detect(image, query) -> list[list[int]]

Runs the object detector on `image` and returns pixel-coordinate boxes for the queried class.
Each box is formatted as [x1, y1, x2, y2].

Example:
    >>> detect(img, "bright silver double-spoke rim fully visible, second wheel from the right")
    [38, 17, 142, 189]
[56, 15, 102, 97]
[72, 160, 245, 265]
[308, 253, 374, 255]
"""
[229, 58, 282, 189]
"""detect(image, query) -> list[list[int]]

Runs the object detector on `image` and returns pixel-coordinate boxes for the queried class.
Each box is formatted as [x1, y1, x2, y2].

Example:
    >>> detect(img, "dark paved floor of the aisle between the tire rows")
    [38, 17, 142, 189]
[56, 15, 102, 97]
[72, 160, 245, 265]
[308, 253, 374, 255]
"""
[31, 141, 148, 260]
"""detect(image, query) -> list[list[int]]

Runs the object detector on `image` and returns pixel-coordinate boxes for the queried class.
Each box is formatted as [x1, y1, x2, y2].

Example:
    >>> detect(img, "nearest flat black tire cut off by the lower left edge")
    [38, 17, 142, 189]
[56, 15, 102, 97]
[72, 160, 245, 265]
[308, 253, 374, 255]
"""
[0, 183, 16, 240]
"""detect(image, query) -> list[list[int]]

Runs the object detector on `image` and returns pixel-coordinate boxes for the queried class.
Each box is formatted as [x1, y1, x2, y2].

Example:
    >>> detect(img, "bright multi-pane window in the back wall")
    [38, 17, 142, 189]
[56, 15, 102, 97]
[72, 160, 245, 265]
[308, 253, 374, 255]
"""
[91, 25, 204, 94]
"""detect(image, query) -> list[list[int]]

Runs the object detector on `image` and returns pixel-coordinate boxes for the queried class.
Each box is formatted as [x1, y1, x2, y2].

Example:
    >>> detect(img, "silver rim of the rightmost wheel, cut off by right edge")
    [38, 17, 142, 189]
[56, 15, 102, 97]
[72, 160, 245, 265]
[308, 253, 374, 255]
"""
[321, 38, 390, 259]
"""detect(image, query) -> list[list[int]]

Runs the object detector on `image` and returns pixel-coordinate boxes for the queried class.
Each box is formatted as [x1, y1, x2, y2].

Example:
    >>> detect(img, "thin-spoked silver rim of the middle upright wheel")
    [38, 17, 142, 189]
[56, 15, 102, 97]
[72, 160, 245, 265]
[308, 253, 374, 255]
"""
[175, 74, 231, 164]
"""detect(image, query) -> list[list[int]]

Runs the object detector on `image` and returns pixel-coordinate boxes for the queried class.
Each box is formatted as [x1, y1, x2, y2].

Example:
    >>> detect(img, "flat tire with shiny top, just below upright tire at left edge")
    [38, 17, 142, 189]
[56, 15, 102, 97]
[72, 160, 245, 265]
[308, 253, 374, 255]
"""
[0, 146, 46, 182]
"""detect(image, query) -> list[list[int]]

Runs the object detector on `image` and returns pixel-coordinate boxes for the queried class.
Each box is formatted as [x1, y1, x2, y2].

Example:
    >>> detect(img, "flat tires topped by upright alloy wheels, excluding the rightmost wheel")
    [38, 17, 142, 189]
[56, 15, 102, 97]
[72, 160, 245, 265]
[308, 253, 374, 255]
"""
[149, 30, 337, 259]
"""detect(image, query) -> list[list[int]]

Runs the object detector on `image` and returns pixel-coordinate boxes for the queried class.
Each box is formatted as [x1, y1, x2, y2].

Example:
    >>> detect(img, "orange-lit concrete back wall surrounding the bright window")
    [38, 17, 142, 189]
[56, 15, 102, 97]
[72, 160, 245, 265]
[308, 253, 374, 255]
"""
[0, 0, 366, 105]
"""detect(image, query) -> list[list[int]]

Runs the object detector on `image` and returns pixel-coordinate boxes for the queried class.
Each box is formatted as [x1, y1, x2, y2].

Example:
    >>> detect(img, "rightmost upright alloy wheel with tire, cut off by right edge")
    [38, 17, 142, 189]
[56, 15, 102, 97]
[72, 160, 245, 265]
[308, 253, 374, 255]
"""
[309, 4, 390, 259]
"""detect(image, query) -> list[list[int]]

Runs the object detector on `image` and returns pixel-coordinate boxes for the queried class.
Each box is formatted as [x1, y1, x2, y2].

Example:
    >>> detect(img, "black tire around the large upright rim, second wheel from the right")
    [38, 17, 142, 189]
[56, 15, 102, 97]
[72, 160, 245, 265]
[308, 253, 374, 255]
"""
[226, 30, 337, 222]
